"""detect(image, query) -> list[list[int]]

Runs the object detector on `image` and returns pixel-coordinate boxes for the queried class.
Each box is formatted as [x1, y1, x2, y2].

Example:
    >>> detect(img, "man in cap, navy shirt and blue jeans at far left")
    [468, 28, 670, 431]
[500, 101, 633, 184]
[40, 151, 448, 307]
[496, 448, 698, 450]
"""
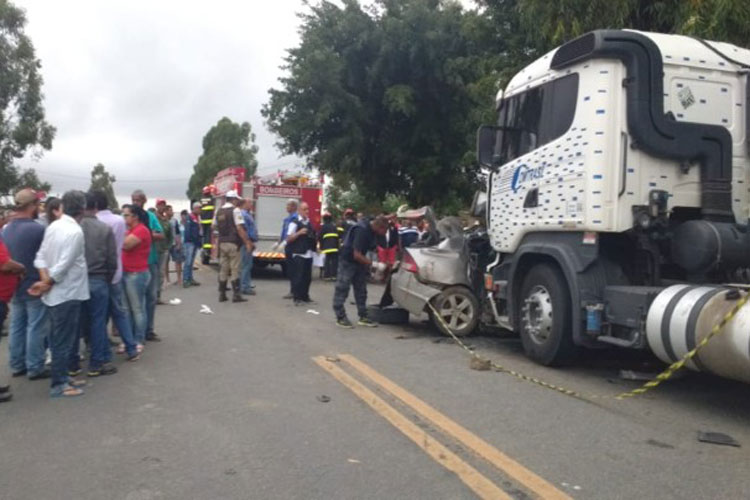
[3, 189, 49, 380]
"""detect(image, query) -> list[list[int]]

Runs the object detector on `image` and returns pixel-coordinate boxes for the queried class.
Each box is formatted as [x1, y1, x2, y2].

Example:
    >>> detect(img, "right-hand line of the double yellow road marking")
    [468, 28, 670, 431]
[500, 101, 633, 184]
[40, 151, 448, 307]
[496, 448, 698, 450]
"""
[339, 354, 570, 499]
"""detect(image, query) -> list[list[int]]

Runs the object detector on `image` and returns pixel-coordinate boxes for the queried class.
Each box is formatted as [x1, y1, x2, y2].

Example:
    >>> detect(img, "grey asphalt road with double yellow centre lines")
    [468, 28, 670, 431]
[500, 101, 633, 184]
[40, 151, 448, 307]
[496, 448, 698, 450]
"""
[0, 270, 750, 500]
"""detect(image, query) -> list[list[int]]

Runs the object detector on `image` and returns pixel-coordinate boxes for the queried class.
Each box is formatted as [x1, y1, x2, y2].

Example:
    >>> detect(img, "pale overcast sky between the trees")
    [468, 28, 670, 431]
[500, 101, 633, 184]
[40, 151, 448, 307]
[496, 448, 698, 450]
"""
[13, 0, 303, 205]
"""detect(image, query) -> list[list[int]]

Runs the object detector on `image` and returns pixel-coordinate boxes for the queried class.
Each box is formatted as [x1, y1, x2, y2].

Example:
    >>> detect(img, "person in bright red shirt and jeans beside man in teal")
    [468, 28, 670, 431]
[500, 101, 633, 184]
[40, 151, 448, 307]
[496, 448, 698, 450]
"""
[122, 205, 151, 353]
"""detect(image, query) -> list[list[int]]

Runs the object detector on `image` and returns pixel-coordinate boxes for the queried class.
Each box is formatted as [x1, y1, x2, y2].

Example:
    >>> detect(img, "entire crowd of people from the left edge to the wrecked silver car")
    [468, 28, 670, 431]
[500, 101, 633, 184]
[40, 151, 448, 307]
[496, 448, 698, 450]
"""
[0, 189, 434, 402]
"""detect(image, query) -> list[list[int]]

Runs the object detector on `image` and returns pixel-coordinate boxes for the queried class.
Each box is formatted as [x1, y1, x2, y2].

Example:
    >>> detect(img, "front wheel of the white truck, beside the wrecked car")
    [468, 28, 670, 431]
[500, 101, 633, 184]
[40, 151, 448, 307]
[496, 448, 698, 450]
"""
[516, 264, 576, 366]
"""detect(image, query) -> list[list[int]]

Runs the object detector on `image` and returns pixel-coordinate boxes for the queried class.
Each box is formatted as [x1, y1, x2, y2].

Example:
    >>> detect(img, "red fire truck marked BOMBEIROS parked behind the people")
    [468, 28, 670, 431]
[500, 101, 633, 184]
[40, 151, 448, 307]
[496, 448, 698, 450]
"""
[206, 167, 323, 268]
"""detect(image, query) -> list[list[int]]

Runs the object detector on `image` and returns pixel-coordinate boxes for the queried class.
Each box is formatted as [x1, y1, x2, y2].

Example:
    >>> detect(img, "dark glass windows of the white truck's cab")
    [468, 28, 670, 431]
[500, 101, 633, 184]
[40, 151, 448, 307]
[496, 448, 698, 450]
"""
[496, 73, 578, 165]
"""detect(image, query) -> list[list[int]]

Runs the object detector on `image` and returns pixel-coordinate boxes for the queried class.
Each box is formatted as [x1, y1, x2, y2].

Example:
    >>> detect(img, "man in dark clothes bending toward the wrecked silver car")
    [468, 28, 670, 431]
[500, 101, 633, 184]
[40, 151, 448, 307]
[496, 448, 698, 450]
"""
[333, 217, 388, 328]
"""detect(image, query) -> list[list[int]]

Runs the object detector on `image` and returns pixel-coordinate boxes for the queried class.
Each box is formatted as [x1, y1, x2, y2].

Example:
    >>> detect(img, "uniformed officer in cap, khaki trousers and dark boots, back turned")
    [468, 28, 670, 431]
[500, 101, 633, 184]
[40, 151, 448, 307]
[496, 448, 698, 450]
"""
[213, 189, 253, 302]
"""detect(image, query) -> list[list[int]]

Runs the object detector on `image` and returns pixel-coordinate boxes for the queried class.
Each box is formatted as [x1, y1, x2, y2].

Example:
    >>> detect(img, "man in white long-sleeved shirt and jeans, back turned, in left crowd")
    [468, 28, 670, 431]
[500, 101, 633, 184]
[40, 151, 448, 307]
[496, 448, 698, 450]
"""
[29, 191, 89, 397]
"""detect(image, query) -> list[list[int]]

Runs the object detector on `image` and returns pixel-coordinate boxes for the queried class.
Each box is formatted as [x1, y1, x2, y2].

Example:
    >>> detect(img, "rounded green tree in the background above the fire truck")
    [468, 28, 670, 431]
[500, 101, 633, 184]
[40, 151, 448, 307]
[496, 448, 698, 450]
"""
[187, 117, 258, 199]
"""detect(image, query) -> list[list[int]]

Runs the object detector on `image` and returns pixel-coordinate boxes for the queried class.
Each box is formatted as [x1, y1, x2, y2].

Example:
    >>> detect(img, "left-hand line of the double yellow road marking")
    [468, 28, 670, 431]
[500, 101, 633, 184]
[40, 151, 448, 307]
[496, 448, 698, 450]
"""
[313, 356, 510, 500]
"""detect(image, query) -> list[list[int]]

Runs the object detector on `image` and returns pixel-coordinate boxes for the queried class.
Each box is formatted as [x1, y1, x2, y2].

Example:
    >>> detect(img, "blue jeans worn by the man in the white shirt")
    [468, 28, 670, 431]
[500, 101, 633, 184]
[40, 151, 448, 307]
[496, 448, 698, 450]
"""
[47, 300, 81, 390]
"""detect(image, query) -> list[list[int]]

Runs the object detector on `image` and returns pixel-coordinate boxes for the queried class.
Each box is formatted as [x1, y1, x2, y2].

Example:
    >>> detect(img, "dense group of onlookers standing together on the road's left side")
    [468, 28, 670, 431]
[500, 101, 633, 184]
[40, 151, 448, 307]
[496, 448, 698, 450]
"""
[0, 189, 201, 402]
